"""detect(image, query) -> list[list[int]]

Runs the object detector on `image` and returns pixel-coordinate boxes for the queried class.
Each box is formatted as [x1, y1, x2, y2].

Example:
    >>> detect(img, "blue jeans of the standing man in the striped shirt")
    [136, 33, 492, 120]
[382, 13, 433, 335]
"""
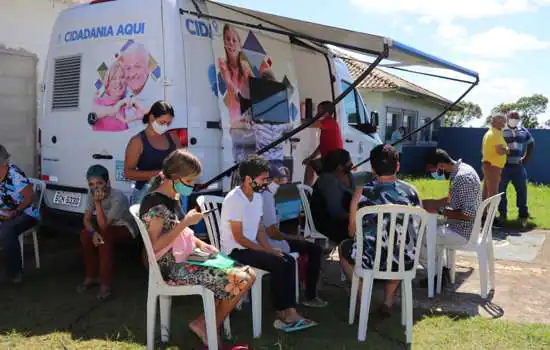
[498, 164, 529, 218]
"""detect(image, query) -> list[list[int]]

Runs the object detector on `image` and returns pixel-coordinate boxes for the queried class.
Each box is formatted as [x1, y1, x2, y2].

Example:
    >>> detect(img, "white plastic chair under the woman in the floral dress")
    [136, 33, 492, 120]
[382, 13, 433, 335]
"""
[130, 204, 231, 350]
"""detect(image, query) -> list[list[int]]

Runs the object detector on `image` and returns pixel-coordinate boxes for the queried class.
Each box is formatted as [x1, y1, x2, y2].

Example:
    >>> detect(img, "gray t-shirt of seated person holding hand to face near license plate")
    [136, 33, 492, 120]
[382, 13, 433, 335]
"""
[87, 188, 138, 237]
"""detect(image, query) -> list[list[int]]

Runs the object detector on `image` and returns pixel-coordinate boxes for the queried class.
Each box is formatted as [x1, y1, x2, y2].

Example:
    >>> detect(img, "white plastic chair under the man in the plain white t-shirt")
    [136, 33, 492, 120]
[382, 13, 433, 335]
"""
[197, 196, 300, 338]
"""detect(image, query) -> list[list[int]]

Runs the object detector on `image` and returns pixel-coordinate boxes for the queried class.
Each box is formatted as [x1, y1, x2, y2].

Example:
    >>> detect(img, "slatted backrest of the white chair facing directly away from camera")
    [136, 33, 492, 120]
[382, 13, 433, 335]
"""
[355, 204, 434, 275]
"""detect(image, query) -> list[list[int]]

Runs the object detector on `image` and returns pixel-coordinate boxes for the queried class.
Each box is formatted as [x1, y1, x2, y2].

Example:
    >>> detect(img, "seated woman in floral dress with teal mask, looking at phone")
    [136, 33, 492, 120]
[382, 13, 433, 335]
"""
[140, 149, 256, 345]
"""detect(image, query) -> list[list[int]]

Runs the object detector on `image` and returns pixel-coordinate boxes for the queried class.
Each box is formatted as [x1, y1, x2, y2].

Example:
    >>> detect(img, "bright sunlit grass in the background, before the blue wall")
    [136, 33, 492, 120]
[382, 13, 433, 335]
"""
[405, 178, 550, 229]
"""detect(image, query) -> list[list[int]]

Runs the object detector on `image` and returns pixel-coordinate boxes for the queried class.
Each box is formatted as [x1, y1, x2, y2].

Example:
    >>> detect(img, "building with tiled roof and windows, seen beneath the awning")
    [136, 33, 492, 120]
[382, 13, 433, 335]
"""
[344, 59, 460, 146]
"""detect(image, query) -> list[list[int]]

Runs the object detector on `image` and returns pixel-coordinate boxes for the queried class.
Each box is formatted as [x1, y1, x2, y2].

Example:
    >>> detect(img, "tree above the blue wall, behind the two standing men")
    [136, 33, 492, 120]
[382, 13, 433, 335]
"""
[485, 94, 548, 128]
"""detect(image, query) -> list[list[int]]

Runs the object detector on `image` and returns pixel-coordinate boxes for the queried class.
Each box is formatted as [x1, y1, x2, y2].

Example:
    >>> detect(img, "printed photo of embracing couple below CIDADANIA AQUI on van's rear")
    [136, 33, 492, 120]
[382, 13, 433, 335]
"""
[88, 40, 161, 132]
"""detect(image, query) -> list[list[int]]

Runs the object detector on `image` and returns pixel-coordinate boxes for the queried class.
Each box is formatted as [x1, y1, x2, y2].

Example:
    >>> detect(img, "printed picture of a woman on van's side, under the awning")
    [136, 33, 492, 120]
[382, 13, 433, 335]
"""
[210, 23, 299, 183]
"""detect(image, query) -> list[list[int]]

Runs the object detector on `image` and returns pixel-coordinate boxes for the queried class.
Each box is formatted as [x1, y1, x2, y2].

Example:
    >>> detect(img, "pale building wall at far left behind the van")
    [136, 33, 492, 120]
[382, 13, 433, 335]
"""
[0, 0, 81, 176]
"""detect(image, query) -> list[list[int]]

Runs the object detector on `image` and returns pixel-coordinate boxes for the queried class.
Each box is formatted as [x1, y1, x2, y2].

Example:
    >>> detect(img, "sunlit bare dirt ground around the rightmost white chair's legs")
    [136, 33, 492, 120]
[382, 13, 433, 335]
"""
[414, 230, 550, 324]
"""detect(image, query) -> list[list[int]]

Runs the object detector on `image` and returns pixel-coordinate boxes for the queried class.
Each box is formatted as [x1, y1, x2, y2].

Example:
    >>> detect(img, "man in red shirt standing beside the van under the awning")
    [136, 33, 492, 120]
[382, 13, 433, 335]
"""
[303, 101, 344, 186]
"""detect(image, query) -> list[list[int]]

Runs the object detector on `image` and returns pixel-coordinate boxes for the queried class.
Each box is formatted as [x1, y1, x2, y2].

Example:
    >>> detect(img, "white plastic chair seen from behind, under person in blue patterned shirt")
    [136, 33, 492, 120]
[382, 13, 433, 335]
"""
[349, 205, 428, 344]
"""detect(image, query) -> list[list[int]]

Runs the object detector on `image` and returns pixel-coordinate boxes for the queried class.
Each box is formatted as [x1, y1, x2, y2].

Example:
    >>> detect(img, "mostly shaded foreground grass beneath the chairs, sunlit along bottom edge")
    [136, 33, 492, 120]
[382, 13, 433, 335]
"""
[0, 235, 550, 350]
